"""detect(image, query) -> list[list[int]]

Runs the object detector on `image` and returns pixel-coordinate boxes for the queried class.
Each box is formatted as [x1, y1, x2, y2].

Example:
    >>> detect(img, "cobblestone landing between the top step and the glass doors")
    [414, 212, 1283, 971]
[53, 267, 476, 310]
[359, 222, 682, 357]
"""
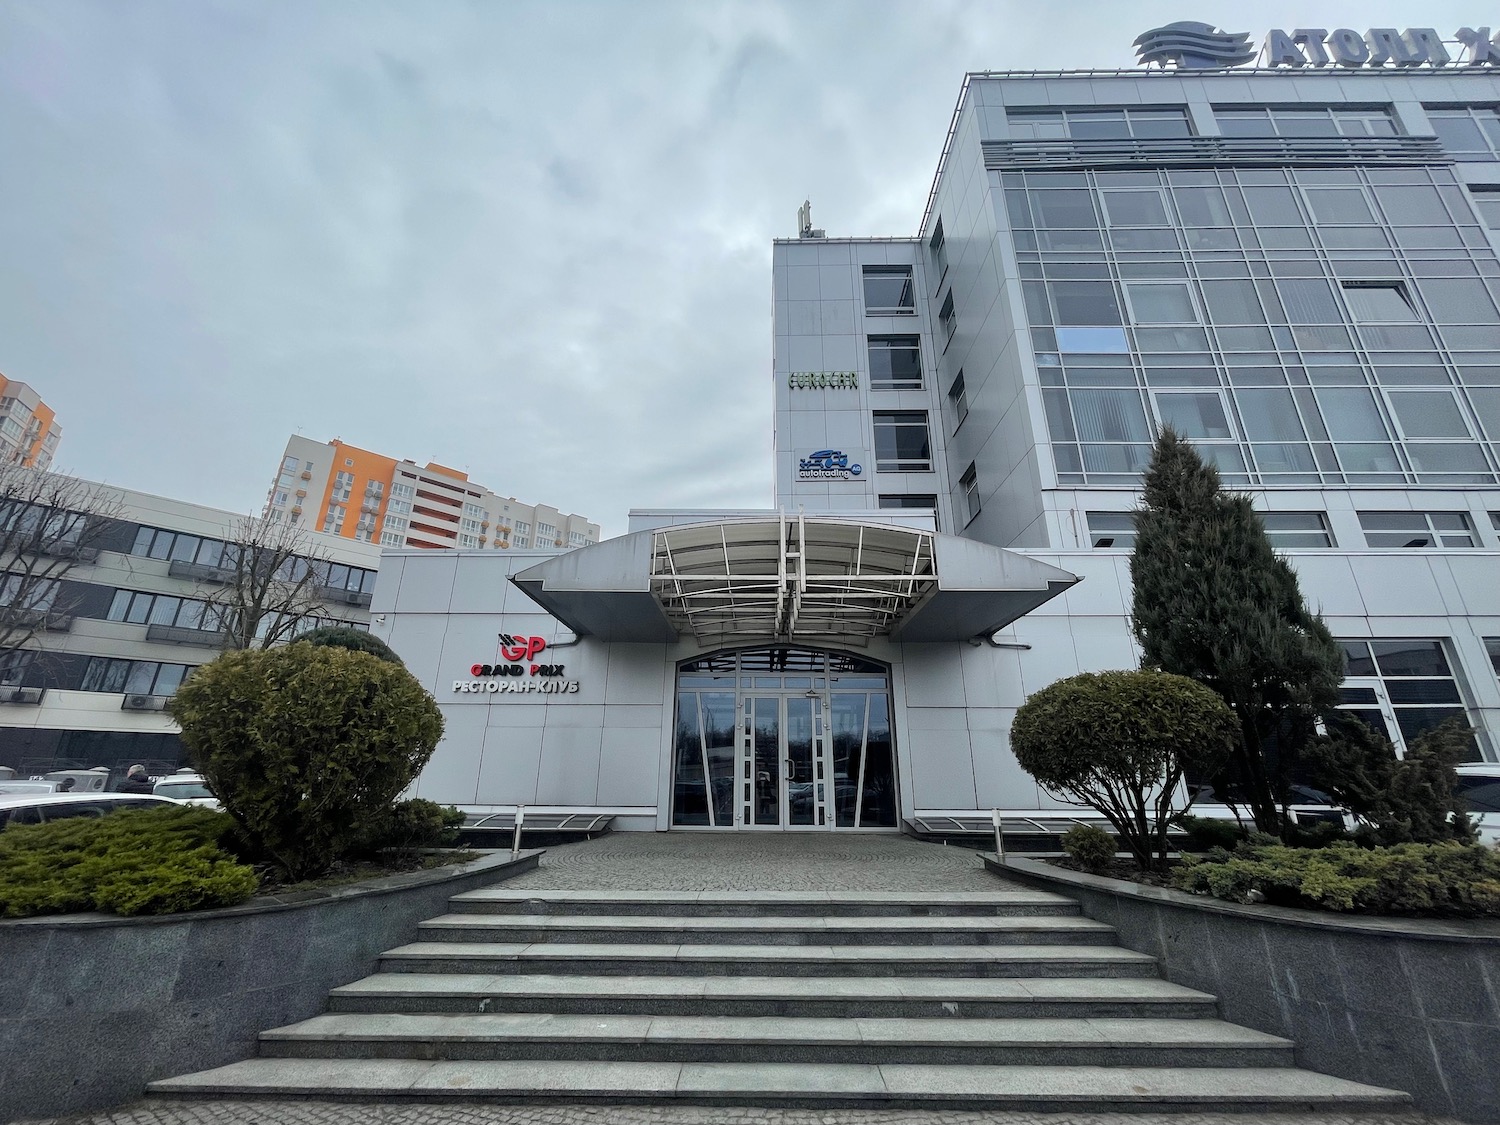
[504, 833, 1013, 891]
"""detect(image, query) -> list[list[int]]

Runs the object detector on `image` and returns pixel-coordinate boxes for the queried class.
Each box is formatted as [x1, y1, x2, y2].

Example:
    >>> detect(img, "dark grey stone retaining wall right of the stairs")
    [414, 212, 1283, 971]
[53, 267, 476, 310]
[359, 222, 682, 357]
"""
[984, 855, 1500, 1122]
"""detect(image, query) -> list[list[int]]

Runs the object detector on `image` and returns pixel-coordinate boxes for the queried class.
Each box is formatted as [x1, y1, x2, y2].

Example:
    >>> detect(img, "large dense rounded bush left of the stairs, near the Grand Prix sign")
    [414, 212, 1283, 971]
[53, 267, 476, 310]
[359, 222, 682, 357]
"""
[171, 644, 443, 882]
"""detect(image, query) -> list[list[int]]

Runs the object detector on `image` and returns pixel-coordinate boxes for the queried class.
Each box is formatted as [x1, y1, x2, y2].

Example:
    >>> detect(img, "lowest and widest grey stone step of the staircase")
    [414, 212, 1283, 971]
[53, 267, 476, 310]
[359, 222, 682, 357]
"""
[146, 1059, 1410, 1113]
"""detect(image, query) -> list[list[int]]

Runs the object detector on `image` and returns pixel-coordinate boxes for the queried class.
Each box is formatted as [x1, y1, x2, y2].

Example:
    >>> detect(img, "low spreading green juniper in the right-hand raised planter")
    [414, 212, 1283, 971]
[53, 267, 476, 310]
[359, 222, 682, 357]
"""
[1173, 843, 1500, 918]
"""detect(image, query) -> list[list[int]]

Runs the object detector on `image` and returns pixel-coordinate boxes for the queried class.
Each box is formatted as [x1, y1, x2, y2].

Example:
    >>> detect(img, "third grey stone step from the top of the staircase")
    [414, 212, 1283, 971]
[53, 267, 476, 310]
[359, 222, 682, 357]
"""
[380, 942, 1157, 977]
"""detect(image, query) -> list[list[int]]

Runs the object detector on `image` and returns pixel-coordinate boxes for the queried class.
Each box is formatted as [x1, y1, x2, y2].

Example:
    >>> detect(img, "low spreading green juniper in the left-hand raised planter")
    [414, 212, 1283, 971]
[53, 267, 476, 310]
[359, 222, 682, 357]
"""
[0, 807, 258, 918]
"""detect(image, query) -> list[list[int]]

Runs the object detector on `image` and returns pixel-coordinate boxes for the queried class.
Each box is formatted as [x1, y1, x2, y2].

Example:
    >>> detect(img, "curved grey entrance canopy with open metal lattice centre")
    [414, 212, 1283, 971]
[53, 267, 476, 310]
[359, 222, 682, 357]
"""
[512, 515, 1079, 645]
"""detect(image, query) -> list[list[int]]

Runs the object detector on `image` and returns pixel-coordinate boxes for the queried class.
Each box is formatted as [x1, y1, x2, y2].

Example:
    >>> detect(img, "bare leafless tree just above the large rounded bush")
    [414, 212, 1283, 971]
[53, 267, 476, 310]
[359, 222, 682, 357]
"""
[203, 516, 330, 650]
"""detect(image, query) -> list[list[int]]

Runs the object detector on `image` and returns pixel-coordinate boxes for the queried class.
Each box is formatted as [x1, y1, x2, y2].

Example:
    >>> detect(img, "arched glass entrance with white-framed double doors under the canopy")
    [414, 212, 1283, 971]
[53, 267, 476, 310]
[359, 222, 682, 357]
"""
[672, 647, 897, 831]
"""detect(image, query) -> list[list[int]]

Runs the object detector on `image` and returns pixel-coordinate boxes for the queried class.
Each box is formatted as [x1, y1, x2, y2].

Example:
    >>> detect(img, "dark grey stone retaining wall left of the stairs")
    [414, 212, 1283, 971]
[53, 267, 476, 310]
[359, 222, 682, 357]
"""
[0, 851, 542, 1121]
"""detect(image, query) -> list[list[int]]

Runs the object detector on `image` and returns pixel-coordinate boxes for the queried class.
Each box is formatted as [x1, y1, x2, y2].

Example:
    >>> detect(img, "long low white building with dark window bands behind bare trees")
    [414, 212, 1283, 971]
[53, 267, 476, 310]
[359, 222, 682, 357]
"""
[0, 483, 380, 777]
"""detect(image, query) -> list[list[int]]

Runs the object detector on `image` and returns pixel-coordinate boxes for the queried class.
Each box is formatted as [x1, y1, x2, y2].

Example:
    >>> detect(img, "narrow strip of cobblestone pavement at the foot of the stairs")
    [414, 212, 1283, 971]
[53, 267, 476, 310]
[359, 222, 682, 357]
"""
[17, 1101, 1458, 1125]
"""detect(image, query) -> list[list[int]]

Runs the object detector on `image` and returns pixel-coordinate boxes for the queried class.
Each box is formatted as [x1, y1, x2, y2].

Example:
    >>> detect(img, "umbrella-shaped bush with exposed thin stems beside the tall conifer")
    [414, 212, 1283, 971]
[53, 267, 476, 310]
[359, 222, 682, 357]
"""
[1011, 672, 1239, 867]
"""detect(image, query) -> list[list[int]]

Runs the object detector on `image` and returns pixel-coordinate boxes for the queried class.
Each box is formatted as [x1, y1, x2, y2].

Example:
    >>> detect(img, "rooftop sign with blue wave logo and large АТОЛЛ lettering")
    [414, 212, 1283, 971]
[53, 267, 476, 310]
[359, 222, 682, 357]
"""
[1136, 20, 1500, 71]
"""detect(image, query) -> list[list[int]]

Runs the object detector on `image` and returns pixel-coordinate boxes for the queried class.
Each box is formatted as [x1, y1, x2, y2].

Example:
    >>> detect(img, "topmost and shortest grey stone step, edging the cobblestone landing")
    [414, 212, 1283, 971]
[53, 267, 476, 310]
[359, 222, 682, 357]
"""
[449, 887, 1080, 918]
